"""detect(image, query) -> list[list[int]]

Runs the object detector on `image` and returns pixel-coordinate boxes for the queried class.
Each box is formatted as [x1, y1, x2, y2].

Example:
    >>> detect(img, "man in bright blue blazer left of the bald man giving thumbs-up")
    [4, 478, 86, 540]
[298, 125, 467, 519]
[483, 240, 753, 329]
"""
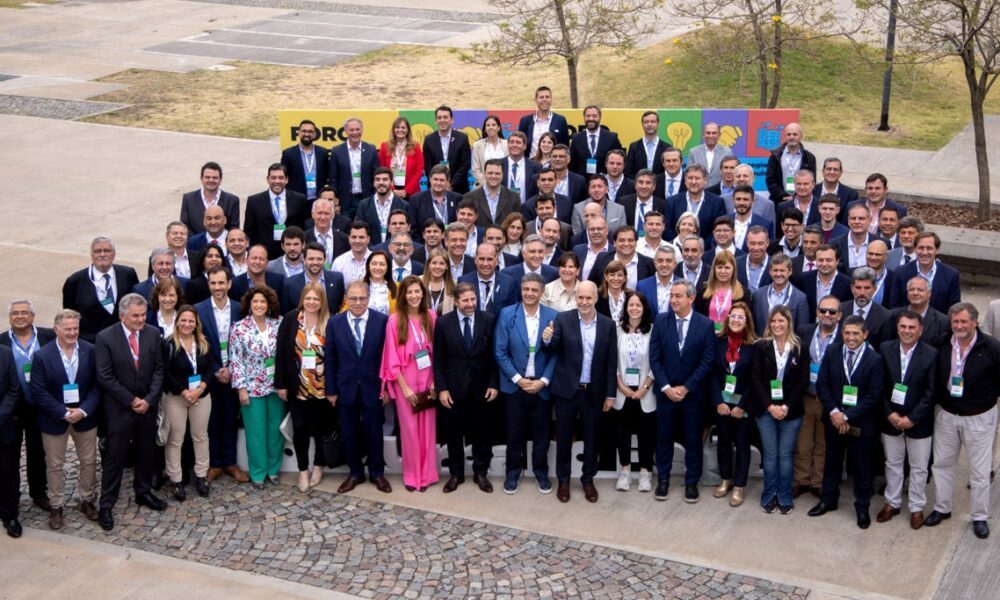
[493, 273, 558, 494]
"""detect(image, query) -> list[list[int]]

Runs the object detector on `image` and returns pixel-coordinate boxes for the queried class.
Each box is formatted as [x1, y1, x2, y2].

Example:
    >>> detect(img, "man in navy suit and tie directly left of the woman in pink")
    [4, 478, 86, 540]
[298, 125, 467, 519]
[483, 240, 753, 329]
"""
[324, 280, 392, 494]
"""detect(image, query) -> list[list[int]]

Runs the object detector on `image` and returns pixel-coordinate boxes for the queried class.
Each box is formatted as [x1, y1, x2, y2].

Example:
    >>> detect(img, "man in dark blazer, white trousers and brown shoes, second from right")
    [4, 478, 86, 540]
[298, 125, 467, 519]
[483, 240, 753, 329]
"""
[876, 311, 938, 529]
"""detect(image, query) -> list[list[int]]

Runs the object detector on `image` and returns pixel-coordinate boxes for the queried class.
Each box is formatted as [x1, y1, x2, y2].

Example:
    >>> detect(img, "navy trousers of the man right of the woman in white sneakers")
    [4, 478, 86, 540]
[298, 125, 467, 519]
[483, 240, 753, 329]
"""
[656, 393, 705, 485]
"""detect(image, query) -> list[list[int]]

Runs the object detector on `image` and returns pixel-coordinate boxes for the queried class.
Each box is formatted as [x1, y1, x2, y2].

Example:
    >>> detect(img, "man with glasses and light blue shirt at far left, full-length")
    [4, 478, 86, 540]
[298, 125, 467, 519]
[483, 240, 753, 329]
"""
[0, 300, 55, 511]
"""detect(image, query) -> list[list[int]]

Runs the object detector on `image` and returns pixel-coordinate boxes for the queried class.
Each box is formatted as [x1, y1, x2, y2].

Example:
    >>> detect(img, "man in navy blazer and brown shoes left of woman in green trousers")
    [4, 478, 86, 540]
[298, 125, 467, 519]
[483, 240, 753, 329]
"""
[194, 270, 248, 483]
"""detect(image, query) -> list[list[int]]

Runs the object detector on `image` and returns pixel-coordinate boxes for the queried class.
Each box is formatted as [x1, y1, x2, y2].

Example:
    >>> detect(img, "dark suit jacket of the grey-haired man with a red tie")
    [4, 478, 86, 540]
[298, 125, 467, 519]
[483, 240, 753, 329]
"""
[94, 323, 163, 432]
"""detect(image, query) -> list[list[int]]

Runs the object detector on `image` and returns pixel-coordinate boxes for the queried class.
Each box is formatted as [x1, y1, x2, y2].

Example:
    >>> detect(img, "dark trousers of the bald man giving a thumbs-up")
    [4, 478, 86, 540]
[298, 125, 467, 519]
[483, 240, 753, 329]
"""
[555, 389, 601, 483]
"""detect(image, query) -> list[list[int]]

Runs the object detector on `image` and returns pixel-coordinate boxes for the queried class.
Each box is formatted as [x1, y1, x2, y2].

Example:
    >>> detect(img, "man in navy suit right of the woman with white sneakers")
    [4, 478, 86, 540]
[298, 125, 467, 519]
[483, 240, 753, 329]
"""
[649, 280, 716, 503]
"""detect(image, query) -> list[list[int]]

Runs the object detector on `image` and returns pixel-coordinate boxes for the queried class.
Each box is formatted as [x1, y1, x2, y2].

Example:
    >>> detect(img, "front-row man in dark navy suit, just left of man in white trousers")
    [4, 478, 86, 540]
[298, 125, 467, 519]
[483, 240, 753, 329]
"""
[809, 315, 884, 529]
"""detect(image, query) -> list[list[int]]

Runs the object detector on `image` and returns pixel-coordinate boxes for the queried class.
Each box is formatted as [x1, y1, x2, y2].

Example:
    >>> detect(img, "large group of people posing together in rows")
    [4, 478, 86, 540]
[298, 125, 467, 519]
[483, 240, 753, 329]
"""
[0, 87, 1000, 538]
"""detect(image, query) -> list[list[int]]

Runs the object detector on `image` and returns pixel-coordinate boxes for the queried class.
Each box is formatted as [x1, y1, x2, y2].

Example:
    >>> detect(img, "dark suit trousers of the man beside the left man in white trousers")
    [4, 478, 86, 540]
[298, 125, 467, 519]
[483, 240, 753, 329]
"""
[821, 416, 877, 509]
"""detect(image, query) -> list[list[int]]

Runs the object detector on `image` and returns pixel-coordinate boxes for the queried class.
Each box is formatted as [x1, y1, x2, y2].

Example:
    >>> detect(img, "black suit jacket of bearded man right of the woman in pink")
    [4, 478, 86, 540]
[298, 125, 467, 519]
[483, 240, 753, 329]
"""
[434, 309, 500, 403]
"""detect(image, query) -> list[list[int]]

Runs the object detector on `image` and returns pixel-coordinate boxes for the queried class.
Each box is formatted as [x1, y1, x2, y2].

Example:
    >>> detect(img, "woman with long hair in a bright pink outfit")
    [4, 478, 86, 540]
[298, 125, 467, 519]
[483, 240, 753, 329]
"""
[380, 275, 438, 492]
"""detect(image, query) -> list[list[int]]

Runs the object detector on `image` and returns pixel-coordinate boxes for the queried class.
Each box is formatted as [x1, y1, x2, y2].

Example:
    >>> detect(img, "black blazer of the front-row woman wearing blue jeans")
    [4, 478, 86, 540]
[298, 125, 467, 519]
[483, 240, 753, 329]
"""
[750, 340, 809, 419]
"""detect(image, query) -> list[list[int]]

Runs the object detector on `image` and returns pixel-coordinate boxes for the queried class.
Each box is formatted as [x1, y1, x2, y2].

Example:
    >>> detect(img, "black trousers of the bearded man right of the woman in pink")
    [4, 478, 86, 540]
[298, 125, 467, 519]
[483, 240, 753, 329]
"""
[446, 390, 493, 477]
